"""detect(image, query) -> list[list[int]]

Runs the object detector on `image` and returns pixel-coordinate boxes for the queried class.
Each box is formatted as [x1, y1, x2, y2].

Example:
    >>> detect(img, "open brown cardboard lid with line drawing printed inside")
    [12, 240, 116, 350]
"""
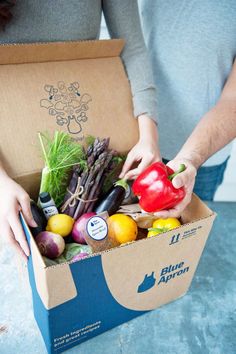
[0, 40, 138, 185]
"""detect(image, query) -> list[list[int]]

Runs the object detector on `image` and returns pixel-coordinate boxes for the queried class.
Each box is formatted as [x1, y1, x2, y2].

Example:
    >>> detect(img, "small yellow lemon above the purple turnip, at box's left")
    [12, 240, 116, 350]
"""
[46, 214, 75, 237]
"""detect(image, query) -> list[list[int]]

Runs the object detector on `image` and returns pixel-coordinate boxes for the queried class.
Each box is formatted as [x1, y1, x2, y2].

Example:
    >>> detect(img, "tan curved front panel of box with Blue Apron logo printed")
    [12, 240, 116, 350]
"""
[102, 215, 214, 311]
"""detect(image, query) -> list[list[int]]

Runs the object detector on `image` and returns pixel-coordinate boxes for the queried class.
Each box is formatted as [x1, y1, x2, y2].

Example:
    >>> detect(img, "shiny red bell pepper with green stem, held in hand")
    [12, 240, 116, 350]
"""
[132, 162, 185, 213]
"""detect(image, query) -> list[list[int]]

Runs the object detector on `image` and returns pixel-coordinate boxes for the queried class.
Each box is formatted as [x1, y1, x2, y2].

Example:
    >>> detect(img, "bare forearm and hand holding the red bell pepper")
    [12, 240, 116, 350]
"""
[154, 60, 236, 217]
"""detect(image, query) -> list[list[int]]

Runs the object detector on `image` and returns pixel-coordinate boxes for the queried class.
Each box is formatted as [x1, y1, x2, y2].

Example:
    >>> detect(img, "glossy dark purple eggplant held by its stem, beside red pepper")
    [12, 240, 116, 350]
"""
[93, 179, 128, 216]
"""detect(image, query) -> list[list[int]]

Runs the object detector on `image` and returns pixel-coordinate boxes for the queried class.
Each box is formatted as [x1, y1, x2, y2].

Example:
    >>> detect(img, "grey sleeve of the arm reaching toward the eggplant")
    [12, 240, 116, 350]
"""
[103, 0, 157, 121]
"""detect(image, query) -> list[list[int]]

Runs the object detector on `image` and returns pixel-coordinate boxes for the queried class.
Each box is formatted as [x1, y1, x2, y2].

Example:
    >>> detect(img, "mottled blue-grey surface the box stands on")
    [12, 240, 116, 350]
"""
[0, 203, 236, 354]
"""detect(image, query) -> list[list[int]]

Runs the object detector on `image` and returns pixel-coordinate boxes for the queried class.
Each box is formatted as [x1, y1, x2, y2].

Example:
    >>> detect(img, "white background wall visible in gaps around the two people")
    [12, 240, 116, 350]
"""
[100, 18, 236, 202]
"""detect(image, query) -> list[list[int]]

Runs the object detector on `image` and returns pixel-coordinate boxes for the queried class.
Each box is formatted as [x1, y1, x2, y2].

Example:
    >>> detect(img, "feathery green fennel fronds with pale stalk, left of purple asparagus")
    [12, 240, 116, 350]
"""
[38, 131, 86, 207]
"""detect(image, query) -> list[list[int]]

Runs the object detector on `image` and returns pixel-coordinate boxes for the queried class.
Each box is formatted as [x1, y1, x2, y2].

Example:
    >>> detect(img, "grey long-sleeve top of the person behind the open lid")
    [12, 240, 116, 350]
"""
[0, 0, 157, 119]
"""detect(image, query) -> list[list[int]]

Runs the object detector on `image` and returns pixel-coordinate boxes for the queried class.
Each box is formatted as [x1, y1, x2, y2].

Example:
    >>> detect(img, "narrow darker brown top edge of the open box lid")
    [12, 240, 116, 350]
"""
[0, 39, 125, 65]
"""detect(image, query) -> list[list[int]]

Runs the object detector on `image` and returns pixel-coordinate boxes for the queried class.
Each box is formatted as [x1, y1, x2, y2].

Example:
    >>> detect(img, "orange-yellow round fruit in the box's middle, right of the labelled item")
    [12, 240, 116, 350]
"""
[107, 214, 138, 244]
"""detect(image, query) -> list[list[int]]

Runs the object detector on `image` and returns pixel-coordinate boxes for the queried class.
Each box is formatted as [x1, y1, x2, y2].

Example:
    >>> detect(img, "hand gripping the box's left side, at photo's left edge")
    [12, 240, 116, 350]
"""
[0, 175, 37, 260]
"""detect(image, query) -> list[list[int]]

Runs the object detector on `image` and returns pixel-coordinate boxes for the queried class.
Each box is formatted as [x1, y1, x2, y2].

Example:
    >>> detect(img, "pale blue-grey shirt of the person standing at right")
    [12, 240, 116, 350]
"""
[139, 0, 236, 166]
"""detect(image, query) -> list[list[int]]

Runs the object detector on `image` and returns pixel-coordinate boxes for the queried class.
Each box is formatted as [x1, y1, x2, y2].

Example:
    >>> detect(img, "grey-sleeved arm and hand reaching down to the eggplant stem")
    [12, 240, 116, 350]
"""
[103, 0, 160, 178]
